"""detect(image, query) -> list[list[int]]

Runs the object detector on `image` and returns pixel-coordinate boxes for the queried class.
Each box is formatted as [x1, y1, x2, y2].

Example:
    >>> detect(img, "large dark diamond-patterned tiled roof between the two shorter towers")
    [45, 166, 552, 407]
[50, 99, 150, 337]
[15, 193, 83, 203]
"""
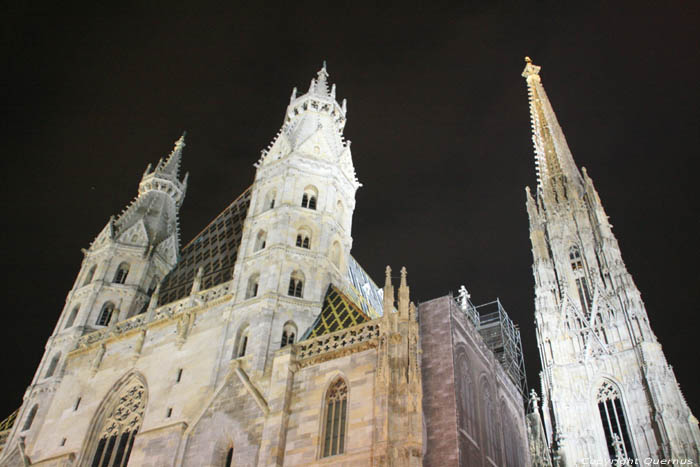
[159, 188, 251, 305]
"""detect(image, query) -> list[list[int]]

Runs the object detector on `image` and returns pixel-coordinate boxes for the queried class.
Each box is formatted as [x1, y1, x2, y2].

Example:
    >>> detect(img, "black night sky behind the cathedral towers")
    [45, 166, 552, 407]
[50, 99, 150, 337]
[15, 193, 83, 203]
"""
[0, 1, 700, 419]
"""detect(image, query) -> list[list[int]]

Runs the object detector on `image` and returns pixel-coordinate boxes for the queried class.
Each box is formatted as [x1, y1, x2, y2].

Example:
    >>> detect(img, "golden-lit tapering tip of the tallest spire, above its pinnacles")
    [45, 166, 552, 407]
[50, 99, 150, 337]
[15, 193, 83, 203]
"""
[522, 57, 583, 201]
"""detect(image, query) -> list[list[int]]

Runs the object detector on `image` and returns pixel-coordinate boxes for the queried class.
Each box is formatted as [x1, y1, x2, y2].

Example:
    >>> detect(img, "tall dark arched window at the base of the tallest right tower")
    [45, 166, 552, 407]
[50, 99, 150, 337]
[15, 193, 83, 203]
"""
[598, 381, 634, 460]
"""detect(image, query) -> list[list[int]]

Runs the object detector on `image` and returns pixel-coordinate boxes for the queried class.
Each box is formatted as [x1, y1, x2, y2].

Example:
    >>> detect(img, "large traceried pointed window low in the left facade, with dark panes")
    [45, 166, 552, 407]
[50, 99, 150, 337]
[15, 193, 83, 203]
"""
[90, 379, 146, 467]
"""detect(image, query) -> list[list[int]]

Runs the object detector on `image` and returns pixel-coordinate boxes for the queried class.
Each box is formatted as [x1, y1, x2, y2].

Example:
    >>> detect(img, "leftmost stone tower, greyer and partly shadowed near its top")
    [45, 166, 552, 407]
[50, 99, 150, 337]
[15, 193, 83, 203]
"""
[4, 135, 187, 458]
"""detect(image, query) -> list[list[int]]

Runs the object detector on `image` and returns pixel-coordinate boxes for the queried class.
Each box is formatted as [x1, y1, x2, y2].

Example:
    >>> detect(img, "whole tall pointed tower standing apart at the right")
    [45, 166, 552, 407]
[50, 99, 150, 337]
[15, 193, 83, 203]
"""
[522, 58, 700, 465]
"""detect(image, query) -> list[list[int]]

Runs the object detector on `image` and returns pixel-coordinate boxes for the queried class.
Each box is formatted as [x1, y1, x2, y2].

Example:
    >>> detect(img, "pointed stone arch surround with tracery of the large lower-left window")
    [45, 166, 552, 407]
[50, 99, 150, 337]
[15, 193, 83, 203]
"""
[76, 371, 148, 466]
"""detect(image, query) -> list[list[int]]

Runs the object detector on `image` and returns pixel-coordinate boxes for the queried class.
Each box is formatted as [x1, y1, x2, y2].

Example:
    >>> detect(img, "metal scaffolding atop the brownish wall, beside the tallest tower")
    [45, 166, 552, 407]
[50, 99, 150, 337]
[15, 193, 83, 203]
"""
[456, 287, 527, 400]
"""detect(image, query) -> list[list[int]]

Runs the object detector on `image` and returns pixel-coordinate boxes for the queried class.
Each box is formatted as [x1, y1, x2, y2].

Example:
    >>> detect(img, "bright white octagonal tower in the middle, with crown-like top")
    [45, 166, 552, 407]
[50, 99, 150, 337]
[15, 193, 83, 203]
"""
[227, 63, 360, 372]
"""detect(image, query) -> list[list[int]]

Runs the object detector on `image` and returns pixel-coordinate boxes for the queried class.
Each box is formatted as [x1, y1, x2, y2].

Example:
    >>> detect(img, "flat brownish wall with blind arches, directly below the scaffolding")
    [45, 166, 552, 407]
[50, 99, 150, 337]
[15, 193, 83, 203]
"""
[418, 296, 530, 467]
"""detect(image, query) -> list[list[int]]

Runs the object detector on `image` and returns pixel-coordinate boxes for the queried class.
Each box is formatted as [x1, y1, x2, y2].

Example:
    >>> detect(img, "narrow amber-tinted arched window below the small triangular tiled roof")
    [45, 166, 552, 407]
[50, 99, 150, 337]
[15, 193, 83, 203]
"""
[321, 378, 348, 457]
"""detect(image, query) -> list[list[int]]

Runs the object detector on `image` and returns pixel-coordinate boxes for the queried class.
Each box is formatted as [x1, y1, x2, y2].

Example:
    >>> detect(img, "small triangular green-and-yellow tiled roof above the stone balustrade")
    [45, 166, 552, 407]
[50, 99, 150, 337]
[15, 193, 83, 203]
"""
[301, 284, 371, 340]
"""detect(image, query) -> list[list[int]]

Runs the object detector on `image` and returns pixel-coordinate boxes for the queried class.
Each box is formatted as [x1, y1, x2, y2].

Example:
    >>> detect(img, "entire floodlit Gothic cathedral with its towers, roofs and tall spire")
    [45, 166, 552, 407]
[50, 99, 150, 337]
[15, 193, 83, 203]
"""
[0, 59, 700, 467]
